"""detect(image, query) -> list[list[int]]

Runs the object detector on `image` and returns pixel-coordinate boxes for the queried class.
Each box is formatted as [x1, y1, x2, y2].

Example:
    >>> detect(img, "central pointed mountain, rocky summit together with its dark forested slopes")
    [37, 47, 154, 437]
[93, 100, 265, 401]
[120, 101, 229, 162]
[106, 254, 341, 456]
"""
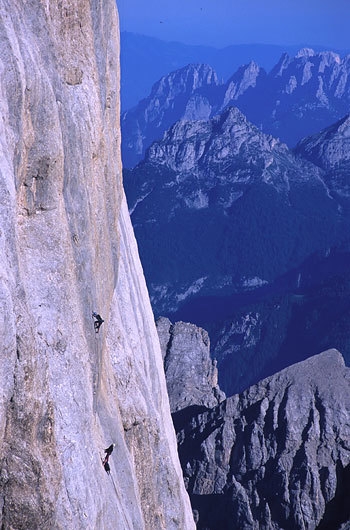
[125, 100, 340, 323]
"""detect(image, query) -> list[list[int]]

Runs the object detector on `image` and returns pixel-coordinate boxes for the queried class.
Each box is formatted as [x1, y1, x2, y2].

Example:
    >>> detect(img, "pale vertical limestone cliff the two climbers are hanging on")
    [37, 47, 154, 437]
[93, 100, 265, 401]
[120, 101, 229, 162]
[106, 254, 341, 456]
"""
[0, 0, 194, 530]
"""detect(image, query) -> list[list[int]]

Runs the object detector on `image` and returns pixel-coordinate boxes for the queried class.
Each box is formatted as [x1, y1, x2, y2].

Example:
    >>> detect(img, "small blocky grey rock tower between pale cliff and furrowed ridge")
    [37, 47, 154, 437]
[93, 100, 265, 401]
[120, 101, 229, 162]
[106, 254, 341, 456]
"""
[156, 317, 225, 412]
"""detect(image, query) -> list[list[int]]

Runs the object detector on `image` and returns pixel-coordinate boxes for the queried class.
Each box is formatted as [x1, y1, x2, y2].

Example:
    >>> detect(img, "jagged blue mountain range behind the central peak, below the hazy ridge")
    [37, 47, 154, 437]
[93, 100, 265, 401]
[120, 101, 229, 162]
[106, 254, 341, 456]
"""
[121, 48, 350, 168]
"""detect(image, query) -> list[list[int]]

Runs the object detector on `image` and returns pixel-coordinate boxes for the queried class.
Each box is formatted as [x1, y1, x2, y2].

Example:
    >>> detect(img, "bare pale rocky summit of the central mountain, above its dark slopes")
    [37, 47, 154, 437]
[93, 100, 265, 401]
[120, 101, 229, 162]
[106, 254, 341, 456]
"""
[145, 106, 288, 173]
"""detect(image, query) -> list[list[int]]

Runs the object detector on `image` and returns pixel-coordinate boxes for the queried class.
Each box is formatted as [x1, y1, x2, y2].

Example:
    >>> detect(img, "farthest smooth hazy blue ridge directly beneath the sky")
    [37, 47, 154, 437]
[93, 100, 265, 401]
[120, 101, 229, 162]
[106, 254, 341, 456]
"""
[120, 31, 349, 111]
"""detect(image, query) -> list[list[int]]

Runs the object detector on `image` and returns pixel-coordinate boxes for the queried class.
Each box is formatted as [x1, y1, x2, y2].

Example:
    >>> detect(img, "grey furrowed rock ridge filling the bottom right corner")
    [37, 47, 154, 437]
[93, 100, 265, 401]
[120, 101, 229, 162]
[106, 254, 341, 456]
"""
[173, 350, 350, 530]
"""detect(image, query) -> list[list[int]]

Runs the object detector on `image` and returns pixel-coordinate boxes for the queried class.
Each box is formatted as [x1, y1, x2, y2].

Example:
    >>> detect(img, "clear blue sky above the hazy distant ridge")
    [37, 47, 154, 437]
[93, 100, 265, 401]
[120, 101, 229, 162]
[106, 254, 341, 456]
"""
[117, 0, 350, 48]
